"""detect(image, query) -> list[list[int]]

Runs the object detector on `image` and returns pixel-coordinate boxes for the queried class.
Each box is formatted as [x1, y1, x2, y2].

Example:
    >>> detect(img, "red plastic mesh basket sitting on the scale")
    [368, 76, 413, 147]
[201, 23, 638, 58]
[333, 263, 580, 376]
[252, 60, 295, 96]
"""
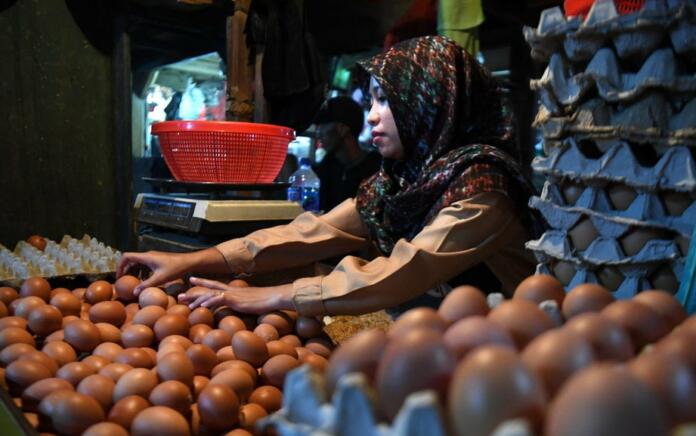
[152, 121, 295, 183]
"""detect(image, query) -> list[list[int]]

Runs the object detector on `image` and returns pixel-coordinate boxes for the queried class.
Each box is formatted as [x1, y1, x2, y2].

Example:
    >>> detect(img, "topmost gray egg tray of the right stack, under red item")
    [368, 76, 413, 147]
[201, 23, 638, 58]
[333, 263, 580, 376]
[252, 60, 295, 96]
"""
[523, 0, 696, 62]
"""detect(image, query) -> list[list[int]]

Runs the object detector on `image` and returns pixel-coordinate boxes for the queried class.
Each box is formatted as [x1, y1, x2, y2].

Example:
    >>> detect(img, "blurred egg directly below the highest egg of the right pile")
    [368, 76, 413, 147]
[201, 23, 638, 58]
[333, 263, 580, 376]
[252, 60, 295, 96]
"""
[488, 300, 555, 350]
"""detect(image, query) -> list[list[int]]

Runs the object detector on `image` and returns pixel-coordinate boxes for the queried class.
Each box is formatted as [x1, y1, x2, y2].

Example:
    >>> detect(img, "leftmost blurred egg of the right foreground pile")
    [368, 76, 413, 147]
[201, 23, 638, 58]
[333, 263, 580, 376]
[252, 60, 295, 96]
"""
[324, 328, 388, 394]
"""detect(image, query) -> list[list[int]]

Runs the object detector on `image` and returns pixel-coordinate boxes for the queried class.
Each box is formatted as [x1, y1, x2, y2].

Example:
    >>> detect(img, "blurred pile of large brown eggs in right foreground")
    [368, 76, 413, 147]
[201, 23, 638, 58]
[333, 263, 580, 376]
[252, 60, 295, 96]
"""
[326, 275, 696, 436]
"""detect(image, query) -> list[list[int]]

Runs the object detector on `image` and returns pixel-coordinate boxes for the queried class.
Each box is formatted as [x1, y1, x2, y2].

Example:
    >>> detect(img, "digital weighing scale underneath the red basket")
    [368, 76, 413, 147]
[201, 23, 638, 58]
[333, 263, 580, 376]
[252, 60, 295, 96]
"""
[134, 177, 304, 252]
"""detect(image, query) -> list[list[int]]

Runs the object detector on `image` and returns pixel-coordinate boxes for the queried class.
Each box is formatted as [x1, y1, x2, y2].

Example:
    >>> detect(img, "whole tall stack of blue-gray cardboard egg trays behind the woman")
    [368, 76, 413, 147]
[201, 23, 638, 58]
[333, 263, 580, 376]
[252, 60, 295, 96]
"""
[525, 0, 696, 299]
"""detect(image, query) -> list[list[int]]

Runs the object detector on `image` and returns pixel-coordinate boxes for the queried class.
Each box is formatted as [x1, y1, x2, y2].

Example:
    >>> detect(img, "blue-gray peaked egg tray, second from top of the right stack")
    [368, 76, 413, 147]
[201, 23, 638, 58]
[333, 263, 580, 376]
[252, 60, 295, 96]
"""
[530, 46, 696, 114]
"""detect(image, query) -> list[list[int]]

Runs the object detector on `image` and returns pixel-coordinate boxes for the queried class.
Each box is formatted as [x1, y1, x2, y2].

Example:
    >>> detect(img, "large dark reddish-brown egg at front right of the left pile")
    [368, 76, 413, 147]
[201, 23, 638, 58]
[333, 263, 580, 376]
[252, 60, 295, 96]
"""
[198, 384, 239, 431]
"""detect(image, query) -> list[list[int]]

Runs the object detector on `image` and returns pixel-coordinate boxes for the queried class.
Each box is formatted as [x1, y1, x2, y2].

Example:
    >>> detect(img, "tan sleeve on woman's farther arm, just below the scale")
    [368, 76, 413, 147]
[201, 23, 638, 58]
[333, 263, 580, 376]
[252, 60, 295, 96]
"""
[216, 199, 367, 274]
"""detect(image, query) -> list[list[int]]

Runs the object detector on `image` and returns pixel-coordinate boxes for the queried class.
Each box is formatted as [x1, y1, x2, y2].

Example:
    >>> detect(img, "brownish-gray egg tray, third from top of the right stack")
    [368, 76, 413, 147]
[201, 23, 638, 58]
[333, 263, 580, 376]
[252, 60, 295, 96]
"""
[534, 91, 696, 146]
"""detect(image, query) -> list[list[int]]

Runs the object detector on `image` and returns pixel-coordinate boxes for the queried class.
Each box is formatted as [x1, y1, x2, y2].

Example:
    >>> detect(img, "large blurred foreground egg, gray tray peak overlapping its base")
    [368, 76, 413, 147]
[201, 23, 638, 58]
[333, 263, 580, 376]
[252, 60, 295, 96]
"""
[447, 345, 545, 435]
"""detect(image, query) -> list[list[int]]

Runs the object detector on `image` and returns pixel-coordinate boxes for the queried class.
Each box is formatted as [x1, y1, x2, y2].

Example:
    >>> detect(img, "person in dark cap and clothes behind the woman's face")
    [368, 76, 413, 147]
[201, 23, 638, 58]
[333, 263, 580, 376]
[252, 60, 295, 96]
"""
[314, 96, 382, 210]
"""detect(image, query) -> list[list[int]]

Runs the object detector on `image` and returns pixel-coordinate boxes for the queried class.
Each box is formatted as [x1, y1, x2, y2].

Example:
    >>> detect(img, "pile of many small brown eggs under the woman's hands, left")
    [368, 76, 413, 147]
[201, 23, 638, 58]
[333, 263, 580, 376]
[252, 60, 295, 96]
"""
[0, 276, 333, 436]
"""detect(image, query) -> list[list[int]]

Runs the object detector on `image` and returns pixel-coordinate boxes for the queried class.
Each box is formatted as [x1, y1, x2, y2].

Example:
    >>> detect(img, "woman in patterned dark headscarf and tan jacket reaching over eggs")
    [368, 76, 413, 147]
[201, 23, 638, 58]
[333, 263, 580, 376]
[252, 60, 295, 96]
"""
[119, 36, 535, 316]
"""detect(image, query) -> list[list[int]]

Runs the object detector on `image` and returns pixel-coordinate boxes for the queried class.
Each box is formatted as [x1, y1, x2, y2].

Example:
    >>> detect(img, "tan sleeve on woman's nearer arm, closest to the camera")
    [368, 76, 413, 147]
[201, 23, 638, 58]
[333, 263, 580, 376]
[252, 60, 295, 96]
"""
[293, 192, 519, 316]
